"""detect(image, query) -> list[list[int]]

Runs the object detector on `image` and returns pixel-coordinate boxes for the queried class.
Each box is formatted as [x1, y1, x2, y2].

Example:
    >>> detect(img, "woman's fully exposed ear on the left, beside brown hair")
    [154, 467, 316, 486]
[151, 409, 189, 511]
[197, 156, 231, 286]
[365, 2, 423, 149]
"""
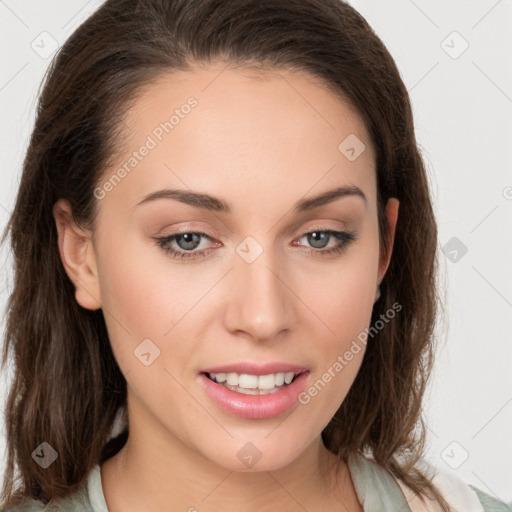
[53, 199, 101, 310]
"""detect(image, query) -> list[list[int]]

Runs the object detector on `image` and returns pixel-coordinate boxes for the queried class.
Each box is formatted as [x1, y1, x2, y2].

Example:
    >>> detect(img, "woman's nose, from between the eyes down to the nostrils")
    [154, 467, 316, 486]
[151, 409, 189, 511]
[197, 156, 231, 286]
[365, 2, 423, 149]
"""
[225, 242, 294, 341]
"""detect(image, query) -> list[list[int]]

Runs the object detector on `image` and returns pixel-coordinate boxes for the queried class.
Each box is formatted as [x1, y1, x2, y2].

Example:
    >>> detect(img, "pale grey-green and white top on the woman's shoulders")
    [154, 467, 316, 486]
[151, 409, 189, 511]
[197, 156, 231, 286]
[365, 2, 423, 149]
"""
[4, 453, 512, 512]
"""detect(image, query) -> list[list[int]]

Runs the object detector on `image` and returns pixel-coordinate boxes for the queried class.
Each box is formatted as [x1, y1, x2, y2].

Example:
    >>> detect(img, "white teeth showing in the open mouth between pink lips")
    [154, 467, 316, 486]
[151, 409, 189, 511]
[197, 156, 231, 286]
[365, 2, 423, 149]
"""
[203, 370, 307, 395]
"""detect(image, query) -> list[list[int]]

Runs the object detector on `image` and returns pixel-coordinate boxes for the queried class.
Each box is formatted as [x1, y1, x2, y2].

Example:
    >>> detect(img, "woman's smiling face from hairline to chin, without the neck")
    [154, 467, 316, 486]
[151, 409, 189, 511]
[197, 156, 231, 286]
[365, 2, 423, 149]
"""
[59, 65, 398, 470]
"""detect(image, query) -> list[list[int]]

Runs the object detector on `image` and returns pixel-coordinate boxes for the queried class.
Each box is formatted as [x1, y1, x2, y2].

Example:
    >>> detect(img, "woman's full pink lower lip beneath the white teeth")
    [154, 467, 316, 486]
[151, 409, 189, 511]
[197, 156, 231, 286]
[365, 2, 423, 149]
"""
[199, 372, 309, 420]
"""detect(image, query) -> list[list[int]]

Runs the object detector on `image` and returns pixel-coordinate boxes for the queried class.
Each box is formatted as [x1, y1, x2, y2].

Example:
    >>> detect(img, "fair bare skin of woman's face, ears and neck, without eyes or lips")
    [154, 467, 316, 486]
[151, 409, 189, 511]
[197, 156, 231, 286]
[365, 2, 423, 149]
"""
[54, 64, 398, 512]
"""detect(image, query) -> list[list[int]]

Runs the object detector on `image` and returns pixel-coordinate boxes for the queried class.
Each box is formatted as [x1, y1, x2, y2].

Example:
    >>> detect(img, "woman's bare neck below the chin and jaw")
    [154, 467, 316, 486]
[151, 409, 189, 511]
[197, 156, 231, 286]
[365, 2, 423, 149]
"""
[101, 404, 353, 512]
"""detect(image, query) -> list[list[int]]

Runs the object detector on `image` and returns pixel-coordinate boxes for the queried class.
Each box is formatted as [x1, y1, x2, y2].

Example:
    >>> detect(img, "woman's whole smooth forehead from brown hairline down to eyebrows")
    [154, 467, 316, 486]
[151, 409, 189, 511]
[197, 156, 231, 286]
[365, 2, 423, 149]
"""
[99, 64, 375, 215]
